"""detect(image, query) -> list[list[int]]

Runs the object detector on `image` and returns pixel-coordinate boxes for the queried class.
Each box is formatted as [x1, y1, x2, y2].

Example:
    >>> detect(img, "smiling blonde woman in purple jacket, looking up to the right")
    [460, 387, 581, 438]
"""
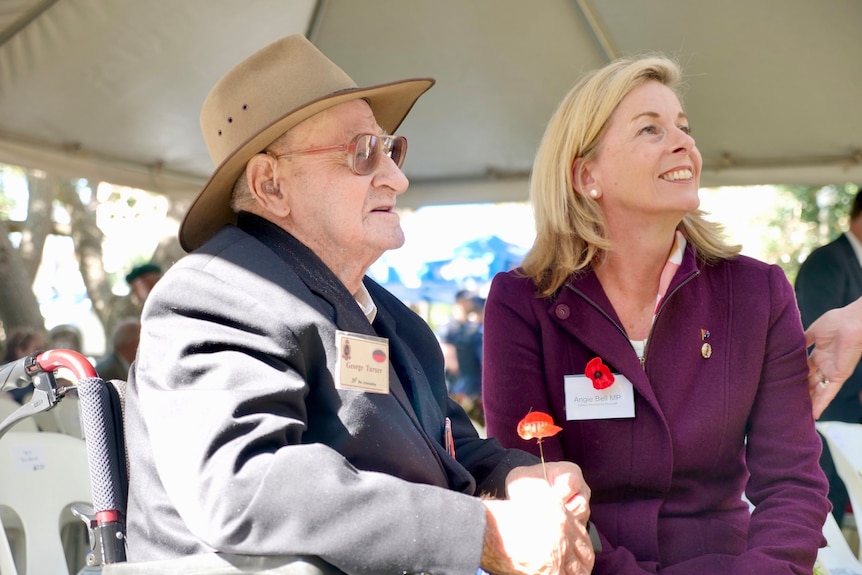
[482, 56, 829, 575]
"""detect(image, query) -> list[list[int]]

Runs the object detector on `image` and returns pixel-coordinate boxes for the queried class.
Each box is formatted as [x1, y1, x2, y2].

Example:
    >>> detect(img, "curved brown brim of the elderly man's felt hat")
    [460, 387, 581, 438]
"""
[179, 78, 434, 252]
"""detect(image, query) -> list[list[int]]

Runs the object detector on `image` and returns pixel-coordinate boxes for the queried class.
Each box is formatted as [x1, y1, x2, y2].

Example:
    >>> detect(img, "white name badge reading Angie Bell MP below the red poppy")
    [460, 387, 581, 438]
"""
[565, 373, 635, 421]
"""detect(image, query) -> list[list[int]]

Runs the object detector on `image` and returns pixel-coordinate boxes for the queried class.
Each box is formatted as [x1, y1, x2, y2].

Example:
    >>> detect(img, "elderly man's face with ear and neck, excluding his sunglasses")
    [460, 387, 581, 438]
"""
[273, 100, 408, 274]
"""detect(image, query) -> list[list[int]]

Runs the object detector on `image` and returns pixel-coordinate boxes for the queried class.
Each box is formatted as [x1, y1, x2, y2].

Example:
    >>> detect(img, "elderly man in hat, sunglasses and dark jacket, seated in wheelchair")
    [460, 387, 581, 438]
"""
[127, 36, 593, 574]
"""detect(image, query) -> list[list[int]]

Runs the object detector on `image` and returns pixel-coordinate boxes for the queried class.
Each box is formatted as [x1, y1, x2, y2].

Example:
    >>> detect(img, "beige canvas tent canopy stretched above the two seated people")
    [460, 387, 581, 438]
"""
[0, 0, 862, 206]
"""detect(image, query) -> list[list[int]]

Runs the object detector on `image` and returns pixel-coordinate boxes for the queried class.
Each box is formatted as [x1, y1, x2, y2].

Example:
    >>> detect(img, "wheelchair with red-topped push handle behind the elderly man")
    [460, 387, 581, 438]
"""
[0, 349, 343, 575]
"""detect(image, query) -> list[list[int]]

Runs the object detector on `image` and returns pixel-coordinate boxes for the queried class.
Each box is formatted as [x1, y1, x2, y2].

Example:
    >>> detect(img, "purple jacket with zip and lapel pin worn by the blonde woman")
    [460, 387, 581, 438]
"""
[483, 245, 829, 575]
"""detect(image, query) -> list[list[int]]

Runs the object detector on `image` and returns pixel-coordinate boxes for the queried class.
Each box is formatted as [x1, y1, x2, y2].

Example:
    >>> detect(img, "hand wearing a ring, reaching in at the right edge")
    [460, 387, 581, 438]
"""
[805, 298, 862, 418]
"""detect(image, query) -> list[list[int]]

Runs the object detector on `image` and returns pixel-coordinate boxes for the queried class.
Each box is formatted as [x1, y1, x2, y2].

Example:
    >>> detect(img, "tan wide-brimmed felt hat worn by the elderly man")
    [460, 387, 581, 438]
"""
[179, 34, 434, 252]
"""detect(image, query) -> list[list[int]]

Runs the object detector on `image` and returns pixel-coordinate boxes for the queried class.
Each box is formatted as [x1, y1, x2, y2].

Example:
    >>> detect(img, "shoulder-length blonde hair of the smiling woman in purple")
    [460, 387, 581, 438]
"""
[521, 54, 740, 297]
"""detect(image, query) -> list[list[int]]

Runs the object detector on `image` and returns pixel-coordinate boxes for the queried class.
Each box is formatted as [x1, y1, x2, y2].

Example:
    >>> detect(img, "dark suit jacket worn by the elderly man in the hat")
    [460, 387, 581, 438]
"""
[126, 214, 538, 575]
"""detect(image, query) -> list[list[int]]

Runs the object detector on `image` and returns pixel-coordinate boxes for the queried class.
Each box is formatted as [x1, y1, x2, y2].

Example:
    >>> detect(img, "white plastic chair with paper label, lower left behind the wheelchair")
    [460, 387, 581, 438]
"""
[0, 432, 92, 575]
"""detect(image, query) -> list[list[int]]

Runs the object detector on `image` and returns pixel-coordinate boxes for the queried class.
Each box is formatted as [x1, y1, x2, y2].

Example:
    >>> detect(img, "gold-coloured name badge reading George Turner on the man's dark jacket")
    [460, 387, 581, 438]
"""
[335, 330, 389, 393]
